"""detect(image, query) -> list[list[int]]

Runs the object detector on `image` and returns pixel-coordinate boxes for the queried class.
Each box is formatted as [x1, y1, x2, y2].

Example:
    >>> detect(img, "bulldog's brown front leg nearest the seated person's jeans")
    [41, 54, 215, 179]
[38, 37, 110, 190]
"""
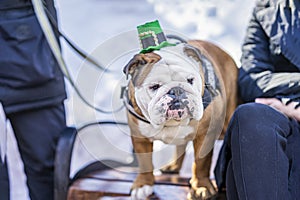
[188, 136, 216, 200]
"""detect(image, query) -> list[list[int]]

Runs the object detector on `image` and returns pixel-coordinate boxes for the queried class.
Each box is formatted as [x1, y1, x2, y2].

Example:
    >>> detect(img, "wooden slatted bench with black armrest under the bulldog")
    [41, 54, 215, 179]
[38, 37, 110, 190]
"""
[54, 127, 226, 200]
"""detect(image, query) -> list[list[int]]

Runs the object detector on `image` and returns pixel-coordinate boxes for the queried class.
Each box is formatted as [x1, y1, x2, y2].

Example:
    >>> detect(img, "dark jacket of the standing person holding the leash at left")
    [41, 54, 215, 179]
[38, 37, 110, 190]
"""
[0, 0, 66, 113]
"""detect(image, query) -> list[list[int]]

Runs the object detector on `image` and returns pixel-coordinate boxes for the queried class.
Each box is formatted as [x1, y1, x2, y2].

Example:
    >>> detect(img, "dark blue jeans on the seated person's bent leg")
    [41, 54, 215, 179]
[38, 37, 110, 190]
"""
[221, 103, 300, 200]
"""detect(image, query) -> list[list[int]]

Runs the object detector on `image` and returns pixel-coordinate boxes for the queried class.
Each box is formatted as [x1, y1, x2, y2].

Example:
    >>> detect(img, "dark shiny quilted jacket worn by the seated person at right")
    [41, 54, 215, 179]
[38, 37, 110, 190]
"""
[238, 0, 300, 102]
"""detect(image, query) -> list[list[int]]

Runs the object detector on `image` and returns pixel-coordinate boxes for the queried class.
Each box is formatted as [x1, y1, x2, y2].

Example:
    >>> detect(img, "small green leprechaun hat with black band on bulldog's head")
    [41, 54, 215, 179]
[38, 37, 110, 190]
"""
[137, 20, 176, 53]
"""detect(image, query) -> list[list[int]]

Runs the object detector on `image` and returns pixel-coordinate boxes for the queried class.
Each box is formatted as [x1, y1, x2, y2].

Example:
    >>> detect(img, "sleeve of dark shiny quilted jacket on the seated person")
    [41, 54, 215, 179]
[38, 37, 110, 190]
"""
[238, 8, 300, 102]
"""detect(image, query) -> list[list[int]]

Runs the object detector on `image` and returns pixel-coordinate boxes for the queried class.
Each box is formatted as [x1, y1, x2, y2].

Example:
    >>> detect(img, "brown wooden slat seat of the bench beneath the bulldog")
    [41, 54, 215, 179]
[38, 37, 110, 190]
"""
[68, 167, 189, 200]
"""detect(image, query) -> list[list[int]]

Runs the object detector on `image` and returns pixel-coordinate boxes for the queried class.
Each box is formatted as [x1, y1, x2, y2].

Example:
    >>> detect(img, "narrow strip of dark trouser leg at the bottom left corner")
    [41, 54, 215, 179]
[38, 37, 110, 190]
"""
[0, 159, 9, 200]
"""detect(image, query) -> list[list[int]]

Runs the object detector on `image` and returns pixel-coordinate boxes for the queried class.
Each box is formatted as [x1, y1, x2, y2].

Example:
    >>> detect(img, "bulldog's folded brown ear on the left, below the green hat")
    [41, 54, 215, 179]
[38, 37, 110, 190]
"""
[123, 52, 161, 77]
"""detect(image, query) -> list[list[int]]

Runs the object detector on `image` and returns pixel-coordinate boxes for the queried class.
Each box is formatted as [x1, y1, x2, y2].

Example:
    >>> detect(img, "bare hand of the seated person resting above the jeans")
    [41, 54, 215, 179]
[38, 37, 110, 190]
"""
[255, 98, 300, 122]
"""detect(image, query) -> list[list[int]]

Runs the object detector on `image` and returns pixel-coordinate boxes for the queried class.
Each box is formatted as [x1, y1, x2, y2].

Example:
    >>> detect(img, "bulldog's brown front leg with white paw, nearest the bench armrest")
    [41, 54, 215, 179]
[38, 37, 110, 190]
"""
[131, 136, 154, 200]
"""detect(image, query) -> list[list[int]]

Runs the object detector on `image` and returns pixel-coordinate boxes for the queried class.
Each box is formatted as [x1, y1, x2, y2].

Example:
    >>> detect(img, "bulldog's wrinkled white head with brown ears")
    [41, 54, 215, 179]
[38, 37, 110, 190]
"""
[124, 44, 204, 128]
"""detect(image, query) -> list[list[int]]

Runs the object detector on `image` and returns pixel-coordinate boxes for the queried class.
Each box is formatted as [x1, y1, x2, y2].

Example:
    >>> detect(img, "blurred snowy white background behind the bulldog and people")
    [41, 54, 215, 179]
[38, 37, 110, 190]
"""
[8, 0, 254, 200]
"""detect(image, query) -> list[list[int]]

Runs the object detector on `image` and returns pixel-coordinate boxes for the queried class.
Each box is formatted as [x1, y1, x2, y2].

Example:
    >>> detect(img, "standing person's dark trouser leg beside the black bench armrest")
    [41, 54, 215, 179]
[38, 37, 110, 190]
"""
[8, 105, 66, 200]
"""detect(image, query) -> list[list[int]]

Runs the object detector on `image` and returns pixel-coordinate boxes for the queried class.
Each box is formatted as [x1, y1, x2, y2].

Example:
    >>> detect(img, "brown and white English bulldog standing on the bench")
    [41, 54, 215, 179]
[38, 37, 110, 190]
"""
[123, 40, 237, 199]
